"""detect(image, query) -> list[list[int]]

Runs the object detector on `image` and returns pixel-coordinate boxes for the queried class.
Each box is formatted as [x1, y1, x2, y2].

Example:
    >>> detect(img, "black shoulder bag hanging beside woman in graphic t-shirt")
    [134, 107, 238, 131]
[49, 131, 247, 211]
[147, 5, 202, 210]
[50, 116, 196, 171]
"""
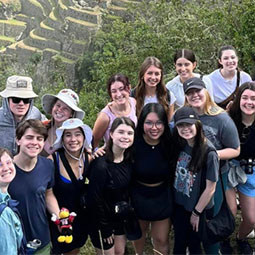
[198, 164, 235, 245]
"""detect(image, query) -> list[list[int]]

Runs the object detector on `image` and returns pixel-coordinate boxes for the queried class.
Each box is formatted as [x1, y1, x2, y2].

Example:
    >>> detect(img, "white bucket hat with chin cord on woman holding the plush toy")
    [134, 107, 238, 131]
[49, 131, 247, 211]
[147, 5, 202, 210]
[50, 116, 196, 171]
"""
[53, 118, 92, 150]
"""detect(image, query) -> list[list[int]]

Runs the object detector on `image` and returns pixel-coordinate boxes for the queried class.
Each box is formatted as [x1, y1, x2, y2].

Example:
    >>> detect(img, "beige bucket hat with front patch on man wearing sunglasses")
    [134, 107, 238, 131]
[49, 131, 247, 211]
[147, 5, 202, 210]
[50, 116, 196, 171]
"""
[0, 75, 38, 98]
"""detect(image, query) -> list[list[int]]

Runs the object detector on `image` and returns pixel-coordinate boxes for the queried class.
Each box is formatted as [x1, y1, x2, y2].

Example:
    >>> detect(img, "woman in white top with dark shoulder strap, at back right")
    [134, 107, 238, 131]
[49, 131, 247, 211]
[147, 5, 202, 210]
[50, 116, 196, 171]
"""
[209, 45, 251, 109]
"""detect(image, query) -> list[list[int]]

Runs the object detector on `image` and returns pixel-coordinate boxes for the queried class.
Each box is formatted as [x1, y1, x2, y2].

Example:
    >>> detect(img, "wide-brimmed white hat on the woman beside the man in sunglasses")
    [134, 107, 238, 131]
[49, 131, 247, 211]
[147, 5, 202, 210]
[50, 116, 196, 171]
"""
[42, 89, 85, 120]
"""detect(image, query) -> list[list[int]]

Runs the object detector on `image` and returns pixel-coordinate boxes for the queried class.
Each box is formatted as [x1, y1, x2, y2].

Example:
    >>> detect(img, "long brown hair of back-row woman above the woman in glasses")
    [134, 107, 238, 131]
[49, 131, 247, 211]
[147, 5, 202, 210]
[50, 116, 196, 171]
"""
[135, 57, 169, 117]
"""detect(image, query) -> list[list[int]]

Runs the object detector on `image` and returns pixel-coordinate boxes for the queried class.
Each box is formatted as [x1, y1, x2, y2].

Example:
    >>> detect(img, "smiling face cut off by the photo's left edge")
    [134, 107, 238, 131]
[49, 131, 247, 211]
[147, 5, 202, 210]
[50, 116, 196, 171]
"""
[0, 152, 16, 188]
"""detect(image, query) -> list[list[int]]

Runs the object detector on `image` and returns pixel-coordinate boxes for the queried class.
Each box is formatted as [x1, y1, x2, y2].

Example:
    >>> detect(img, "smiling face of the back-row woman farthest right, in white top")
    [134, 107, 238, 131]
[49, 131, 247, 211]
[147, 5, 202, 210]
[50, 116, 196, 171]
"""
[219, 50, 238, 72]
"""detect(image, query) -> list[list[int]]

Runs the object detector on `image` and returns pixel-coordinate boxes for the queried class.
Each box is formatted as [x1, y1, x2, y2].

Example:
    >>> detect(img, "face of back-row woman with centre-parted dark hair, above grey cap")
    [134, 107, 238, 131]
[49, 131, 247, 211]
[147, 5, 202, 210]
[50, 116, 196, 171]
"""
[175, 58, 196, 82]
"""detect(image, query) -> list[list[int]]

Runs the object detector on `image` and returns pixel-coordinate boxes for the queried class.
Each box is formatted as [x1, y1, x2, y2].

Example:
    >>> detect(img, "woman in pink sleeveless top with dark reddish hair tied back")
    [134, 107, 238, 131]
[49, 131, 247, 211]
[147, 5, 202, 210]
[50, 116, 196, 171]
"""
[93, 74, 137, 149]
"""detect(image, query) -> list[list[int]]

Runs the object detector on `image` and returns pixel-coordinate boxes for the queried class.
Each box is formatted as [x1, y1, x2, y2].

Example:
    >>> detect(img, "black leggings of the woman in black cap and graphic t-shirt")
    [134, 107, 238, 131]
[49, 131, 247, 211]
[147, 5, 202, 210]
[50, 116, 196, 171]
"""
[173, 204, 202, 255]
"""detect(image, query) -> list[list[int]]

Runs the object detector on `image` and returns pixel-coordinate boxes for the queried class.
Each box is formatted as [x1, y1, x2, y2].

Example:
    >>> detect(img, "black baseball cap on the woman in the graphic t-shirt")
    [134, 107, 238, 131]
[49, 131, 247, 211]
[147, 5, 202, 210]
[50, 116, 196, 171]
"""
[174, 106, 199, 125]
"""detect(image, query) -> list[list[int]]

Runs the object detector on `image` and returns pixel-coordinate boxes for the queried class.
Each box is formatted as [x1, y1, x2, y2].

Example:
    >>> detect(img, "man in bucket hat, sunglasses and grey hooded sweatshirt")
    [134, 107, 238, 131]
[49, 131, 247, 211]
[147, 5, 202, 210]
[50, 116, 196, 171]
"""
[0, 75, 46, 155]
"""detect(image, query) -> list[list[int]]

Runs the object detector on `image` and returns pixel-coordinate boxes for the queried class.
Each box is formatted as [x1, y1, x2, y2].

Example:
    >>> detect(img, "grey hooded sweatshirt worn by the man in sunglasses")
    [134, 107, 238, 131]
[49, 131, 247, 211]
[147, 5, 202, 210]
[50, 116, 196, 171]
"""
[0, 98, 46, 155]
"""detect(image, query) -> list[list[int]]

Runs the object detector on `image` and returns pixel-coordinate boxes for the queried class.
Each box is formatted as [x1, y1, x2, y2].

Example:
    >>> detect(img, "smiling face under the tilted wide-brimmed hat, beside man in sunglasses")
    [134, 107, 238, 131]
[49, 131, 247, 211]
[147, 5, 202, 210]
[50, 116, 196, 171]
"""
[51, 99, 73, 124]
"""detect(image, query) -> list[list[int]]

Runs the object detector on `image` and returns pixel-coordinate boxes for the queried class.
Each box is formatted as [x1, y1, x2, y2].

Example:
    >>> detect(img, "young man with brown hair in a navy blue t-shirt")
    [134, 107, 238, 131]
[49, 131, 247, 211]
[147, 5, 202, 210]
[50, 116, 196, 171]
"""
[8, 120, 59, 254]
